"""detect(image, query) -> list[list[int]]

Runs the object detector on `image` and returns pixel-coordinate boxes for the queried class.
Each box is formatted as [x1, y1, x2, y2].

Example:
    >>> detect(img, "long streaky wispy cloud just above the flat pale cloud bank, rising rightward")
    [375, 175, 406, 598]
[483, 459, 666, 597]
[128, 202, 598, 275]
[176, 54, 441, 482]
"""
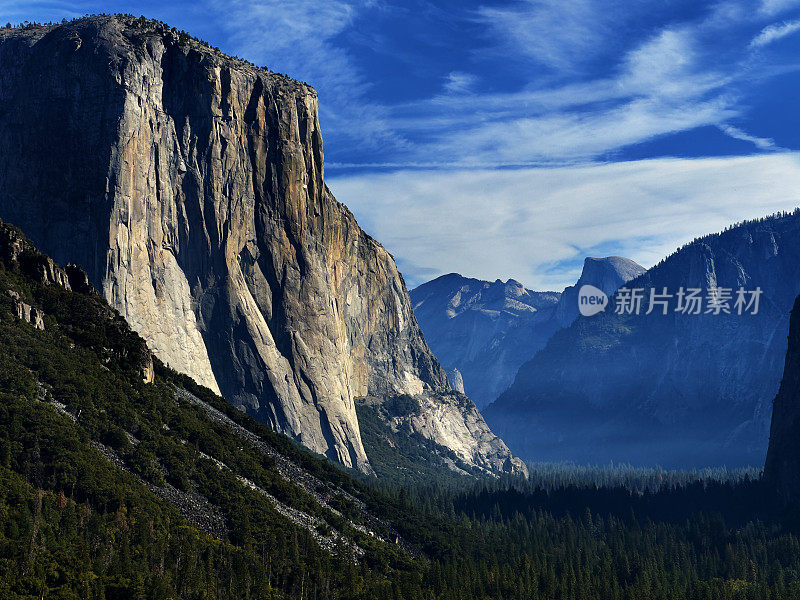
[382, 28, 738, 166]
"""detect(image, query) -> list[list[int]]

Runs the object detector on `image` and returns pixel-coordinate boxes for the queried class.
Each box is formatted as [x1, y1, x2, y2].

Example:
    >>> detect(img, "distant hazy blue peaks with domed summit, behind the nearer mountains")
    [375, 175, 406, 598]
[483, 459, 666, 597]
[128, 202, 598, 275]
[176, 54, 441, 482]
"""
[411, 256, 644, 408]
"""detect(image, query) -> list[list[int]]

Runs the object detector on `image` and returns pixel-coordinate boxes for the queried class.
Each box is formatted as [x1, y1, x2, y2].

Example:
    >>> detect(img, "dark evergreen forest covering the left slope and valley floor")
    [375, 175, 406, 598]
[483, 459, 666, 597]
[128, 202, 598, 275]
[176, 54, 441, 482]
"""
[0, 218, 800, 600]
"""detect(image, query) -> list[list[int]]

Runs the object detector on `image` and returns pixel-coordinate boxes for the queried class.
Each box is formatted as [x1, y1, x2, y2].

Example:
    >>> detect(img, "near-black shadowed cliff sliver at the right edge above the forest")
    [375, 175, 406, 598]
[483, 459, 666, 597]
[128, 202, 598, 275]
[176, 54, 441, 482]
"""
[764, 296, 800, 500]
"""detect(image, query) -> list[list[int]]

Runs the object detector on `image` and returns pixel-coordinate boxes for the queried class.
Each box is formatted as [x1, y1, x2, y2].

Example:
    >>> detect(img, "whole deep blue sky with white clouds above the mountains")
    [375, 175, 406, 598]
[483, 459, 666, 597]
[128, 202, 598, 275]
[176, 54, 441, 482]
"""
[0, 0, 800, 289]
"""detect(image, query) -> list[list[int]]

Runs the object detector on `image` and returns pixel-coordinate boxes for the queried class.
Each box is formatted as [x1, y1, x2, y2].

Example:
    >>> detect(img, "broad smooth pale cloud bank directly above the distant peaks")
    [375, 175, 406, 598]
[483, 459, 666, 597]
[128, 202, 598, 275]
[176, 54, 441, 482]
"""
[329, 153, 800, 289]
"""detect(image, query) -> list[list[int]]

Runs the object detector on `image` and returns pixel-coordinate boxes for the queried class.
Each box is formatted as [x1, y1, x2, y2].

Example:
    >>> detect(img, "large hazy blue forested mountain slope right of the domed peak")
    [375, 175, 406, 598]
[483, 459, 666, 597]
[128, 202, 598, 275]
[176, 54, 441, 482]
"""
[484, 212, 800, 467]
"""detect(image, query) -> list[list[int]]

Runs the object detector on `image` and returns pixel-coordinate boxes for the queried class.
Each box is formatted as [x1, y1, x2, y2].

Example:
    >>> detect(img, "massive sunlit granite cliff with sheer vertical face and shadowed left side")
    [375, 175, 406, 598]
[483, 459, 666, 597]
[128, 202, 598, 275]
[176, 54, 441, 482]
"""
[0, 16, 524, 471]
